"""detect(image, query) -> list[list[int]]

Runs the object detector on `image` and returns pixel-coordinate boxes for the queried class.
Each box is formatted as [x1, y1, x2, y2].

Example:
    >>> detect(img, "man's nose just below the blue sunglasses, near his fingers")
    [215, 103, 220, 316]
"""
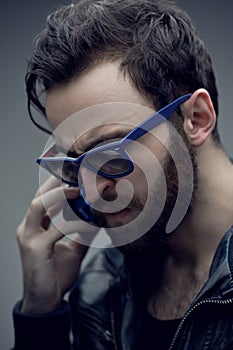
[80, 167, 116, 203]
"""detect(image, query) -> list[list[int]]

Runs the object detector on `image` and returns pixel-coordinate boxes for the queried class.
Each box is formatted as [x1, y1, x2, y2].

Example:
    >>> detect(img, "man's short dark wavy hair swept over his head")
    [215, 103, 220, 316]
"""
[26, 0, 219, 141]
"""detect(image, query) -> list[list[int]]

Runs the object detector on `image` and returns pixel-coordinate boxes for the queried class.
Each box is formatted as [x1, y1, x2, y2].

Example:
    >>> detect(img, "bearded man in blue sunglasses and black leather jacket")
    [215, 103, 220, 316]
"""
[14, 0, 233, 350]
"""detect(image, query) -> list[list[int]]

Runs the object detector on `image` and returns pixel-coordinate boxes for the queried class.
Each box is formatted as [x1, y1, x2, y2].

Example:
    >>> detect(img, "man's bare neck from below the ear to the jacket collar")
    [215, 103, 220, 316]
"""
[147, 148, 233, 319]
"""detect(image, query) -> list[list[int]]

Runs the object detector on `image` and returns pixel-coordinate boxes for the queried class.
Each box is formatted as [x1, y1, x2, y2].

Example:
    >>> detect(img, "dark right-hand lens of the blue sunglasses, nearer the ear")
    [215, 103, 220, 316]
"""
[85, 150, 130, 176]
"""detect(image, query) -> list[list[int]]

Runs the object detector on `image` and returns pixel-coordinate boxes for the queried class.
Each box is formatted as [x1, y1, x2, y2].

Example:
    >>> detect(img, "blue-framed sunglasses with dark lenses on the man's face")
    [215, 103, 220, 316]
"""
[37, 94, 191, 186]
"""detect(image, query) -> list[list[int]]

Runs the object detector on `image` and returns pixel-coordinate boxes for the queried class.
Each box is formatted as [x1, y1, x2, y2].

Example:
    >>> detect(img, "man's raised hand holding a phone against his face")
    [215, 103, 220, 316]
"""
[17, 177, 98, 313]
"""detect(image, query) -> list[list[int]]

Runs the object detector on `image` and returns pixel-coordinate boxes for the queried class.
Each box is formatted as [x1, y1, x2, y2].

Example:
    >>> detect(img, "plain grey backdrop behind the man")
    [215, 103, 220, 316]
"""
[0, 0, 233, 350]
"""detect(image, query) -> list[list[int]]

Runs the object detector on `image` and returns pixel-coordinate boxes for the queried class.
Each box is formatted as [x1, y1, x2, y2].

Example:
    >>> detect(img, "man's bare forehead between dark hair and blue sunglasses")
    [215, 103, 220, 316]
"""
[46, 62, 153, 150]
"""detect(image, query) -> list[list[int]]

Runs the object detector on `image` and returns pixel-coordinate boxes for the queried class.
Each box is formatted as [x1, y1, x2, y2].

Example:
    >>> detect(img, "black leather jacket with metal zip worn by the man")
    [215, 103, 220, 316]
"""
[14, 229, 233, 350]
